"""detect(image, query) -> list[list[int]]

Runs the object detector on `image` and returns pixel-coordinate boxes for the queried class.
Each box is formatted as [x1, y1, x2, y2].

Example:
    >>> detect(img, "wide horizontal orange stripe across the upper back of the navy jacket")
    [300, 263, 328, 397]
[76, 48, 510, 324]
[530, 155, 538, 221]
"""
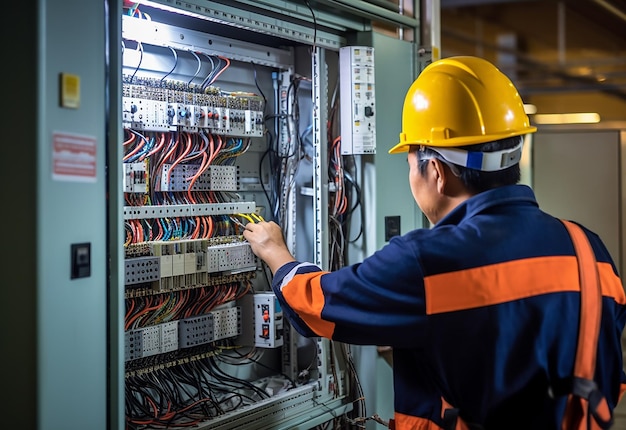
[424, 256, 626, 315]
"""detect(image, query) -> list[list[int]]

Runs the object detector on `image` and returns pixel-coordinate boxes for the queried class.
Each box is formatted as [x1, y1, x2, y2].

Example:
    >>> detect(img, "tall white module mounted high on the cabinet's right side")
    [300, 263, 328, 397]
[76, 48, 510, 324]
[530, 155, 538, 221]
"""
[339, 46, 377, 155]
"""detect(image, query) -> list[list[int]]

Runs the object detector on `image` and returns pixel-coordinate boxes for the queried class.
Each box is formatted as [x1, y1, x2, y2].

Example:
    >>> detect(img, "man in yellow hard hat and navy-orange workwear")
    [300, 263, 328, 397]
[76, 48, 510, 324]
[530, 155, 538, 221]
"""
[244, 57, 626, 430]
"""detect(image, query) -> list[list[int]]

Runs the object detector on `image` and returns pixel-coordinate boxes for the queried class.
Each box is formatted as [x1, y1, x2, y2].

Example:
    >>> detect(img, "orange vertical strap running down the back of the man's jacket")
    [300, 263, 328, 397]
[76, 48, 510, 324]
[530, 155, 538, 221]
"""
[561, 220, 612, 430]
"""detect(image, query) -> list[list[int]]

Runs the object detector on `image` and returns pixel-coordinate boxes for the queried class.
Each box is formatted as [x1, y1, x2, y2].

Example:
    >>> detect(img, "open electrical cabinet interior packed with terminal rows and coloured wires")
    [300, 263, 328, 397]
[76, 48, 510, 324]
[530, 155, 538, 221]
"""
[120, 2, 356, 430]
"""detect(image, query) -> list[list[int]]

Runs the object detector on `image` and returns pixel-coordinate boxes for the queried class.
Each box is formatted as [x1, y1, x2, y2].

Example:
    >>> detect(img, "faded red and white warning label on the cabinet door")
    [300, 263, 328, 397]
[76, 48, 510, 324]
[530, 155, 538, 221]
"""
[52, 132, 96, 182]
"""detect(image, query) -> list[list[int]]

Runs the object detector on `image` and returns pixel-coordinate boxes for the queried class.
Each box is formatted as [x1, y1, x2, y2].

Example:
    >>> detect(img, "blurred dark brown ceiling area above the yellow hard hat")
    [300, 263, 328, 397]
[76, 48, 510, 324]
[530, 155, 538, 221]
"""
[440, 0, 626, 109]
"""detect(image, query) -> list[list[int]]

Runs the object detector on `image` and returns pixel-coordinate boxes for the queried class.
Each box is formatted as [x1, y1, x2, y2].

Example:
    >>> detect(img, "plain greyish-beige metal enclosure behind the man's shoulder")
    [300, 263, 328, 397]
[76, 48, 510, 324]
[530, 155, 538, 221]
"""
[532, 123, 626, 274]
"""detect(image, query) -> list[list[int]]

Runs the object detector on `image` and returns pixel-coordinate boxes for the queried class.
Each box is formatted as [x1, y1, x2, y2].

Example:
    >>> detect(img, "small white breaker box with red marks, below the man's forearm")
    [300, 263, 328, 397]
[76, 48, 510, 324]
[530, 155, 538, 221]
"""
[254, 293, 283, 348]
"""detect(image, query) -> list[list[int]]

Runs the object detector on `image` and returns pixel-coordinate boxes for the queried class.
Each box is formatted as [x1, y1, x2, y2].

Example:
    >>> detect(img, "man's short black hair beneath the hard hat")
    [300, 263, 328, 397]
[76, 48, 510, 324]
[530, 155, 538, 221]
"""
[417, 136, 524, 194]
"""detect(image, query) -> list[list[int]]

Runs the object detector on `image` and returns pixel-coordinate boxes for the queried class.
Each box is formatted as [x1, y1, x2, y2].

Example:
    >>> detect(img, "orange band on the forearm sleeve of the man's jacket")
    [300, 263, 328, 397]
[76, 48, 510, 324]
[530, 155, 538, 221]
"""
[281, 272, 335, 338]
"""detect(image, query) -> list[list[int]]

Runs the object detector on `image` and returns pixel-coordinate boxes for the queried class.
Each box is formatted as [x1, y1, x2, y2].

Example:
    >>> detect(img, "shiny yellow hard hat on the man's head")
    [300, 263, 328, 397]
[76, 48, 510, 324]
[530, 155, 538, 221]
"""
[389, 56, 537, 154]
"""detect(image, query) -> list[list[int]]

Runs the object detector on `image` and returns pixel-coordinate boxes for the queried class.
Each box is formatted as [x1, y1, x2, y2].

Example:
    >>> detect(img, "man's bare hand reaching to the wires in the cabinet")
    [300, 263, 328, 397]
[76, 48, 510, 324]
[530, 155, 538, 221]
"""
[243, 221, 295, 273]
